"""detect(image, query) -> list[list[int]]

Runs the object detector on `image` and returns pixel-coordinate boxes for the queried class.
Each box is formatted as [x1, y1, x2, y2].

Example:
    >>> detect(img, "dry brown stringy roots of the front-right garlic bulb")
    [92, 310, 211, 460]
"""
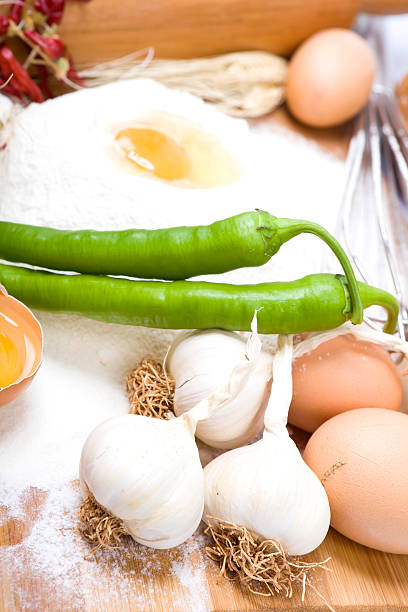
[204, 517, 330, 600]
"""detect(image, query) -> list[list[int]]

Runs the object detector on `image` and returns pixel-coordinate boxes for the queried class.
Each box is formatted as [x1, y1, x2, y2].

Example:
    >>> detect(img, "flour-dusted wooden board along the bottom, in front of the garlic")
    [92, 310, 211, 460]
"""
[0, 491, 408, 612]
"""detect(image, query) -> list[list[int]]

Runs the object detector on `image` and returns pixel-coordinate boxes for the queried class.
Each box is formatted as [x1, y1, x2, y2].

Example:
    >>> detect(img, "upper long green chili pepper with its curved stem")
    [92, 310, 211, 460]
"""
[0, 210, 363, 323]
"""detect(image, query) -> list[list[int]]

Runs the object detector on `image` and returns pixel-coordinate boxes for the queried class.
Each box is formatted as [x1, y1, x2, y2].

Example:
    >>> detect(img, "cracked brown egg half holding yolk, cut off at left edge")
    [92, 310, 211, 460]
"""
[0, 285, 43, 406]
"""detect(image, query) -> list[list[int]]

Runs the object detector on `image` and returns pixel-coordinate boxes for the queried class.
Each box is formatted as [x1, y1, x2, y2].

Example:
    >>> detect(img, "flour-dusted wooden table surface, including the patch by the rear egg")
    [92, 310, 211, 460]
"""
[0, 110, 408, 612]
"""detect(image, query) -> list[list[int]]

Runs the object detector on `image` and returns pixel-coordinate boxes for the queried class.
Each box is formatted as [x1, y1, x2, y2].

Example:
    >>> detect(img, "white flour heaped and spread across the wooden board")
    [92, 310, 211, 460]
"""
[0, 82, 344, 610]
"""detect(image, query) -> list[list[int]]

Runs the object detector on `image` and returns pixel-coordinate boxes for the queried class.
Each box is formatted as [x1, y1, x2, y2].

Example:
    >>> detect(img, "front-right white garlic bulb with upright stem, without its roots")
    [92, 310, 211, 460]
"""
[203, 336, 330, 555]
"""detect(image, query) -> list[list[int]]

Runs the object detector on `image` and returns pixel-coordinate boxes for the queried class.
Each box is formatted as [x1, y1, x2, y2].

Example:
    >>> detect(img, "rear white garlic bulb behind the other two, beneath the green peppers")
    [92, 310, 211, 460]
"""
[166, 326, 272, 449]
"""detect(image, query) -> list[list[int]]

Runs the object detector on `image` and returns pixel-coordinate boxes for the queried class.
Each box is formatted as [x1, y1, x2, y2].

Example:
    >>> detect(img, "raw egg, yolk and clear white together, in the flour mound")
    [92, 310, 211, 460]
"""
[115, 112, 240, 188]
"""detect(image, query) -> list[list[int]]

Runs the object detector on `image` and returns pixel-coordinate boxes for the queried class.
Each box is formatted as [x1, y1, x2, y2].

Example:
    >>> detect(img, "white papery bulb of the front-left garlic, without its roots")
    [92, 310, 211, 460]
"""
[80, 414, 204, 548]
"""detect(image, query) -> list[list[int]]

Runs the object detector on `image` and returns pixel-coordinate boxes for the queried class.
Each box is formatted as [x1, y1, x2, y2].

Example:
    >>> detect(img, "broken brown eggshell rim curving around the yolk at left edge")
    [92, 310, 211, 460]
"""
[0, 285, 43, 406]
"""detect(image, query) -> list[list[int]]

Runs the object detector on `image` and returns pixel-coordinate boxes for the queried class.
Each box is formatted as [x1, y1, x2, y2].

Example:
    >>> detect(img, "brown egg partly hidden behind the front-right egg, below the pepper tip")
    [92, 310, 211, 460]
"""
[288, 335, 402, 432]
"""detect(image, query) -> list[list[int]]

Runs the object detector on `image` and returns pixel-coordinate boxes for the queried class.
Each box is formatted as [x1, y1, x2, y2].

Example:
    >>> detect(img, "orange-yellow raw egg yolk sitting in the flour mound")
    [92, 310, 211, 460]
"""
[116, 128, 191, 181]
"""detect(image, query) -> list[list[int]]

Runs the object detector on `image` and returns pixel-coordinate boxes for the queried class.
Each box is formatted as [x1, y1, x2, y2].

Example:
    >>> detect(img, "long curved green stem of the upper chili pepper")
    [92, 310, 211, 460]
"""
[276, 219, 363, 324]
